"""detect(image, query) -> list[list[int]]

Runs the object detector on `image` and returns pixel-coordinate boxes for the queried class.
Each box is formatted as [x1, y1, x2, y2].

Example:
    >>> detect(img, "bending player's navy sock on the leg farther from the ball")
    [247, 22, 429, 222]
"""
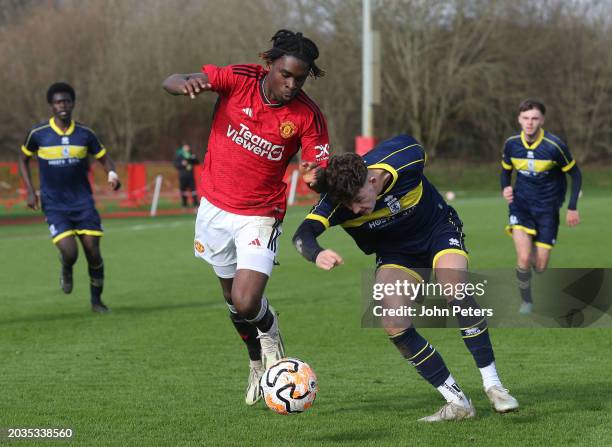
[449, 296, 495, 368]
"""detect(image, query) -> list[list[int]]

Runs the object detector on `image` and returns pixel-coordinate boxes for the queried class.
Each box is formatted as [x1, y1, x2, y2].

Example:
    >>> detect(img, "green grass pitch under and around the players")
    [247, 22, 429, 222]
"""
[0, 195, 612, 446]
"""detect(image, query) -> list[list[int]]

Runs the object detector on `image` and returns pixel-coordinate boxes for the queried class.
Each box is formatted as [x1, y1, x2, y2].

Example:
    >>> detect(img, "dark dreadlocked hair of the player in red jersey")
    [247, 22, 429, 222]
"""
[260, 29, 325, 78]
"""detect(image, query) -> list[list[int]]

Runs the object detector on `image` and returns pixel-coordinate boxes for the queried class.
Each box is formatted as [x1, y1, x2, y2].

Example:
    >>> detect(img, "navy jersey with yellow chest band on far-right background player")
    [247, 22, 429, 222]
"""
[502, 129, 576, 211]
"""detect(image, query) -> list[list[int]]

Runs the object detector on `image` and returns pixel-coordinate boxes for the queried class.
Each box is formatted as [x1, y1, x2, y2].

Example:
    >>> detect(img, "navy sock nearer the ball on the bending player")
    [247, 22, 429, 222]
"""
[389, 327, 450, 388]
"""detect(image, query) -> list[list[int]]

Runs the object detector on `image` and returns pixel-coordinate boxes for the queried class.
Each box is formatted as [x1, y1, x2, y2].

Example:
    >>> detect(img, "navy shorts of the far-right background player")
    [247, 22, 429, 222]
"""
[506, 202, 559, 248]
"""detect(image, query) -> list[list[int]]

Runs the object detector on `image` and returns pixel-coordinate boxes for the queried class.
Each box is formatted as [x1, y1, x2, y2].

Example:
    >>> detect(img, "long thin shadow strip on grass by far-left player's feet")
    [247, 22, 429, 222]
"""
[0, 301, 223, 326]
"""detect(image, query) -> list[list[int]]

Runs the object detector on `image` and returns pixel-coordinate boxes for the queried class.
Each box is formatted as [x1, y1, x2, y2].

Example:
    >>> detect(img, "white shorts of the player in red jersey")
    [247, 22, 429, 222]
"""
[194, 197, 282, 278]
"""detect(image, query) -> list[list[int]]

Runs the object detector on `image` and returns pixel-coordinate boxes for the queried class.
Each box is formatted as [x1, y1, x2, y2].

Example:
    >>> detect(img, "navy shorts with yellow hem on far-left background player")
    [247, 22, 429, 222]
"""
[45, 207, 104, 243]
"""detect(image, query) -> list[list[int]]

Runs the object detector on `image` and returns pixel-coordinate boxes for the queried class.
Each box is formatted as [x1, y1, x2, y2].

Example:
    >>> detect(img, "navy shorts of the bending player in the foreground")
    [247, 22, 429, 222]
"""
[376, 206, 468, 281]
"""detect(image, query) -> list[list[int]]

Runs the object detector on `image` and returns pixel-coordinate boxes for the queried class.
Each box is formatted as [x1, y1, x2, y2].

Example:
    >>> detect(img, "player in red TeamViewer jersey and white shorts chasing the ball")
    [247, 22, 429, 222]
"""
[163, 30, 329, 405]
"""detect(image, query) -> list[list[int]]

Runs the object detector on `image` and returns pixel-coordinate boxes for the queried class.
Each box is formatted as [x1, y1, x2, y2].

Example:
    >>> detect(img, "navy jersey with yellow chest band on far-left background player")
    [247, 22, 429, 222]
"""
[21, 118, 106, 211]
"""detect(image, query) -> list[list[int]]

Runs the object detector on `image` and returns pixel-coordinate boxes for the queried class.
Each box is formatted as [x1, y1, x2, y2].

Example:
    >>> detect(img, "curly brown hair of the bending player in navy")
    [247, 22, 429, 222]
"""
[326, 153, 368, 204]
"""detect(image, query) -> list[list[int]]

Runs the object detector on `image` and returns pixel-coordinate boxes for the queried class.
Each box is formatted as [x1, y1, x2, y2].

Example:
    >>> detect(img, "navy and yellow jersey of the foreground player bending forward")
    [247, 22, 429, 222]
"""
[306, 135, 449, 254]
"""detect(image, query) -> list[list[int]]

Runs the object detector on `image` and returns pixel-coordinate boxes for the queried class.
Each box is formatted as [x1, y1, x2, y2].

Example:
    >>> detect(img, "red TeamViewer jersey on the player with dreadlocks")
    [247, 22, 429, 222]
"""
[202, 64, 329, 219]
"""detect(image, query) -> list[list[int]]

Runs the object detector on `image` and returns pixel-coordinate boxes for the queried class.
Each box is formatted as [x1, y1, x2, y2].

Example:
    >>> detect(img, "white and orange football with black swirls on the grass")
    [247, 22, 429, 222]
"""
[260, 358, 319, 414]
